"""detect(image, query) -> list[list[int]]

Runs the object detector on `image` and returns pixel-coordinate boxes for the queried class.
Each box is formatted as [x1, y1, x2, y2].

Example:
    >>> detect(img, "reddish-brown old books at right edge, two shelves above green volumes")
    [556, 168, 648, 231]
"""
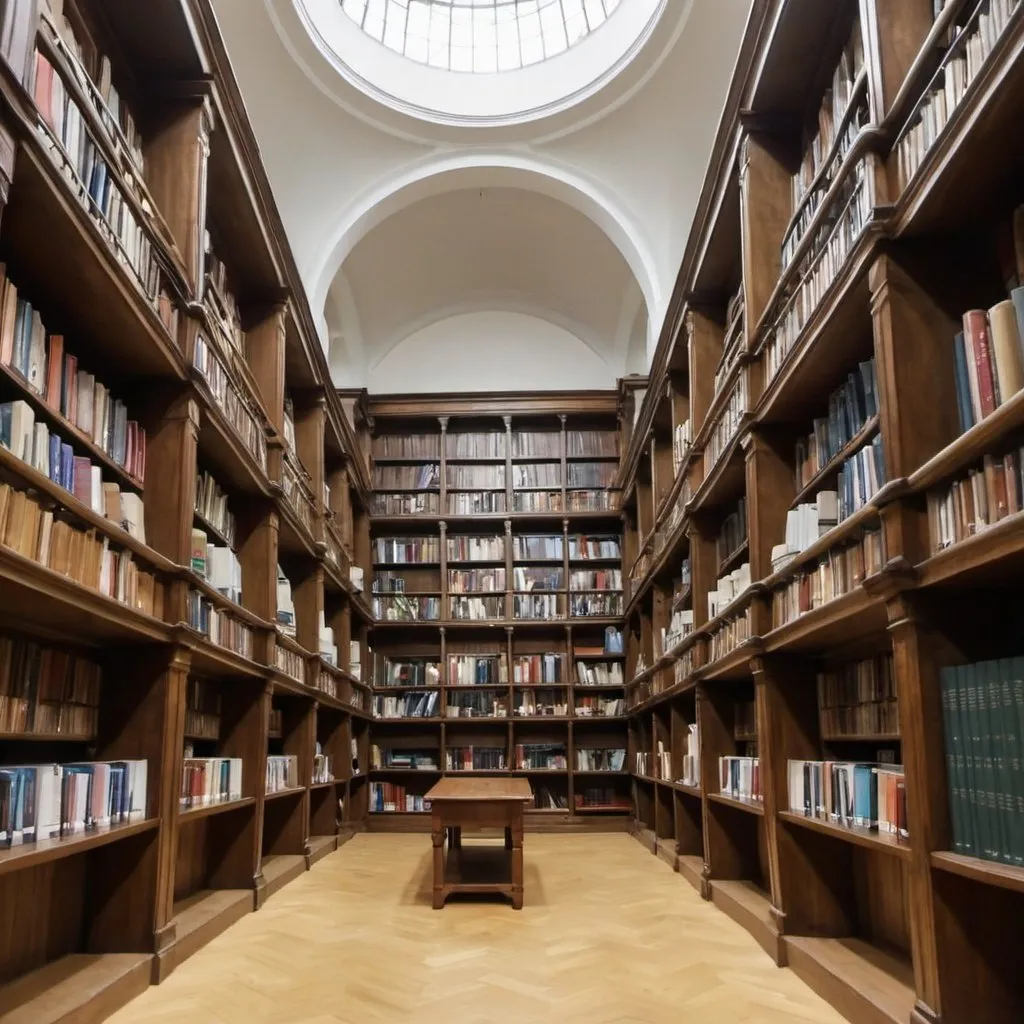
[928, 447, 1024, 552]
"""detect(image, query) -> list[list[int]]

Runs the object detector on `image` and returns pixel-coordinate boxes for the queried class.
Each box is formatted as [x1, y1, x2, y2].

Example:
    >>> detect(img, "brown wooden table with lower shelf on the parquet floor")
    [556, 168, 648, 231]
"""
[426, 776, 534, 910]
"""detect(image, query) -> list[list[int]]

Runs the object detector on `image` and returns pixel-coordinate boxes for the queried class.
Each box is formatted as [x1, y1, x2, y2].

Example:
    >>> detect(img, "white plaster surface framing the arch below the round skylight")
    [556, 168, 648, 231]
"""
[207, 0, 752, 386]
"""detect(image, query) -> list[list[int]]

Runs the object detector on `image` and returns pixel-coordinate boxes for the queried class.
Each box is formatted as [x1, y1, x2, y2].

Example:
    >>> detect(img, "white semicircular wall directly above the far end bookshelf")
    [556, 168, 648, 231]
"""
[366, 310, 616, 394]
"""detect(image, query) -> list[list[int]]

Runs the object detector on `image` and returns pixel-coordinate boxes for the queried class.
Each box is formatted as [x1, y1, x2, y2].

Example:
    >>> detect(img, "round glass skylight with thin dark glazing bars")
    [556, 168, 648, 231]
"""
[339, 0, 621, 74]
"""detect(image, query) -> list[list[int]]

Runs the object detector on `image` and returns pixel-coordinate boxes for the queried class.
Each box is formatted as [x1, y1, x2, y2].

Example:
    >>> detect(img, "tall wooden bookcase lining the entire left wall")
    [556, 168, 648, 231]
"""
[0, 0, 372, 1020]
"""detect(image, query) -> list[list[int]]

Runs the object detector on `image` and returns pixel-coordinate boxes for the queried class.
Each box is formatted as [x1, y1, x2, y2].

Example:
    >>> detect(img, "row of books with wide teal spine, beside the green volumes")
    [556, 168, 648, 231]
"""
[787, 761, 909, 839]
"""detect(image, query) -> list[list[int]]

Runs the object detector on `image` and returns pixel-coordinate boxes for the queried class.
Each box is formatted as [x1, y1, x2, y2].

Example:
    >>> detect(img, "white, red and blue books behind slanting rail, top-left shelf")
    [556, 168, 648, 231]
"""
[31, 50, 159, 301]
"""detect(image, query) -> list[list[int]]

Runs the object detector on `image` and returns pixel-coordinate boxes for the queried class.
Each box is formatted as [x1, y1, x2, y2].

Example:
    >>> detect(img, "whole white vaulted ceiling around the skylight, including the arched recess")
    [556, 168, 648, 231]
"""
[214, 0, 751, 390]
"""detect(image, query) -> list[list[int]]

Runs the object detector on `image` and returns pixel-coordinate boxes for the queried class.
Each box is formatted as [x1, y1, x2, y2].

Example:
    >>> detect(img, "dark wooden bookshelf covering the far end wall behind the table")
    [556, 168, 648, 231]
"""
[369, 392, 631, 829]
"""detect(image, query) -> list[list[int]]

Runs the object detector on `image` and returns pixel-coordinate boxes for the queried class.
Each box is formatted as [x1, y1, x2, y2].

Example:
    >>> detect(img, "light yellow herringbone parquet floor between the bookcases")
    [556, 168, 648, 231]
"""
[110, 835, 843, 1024]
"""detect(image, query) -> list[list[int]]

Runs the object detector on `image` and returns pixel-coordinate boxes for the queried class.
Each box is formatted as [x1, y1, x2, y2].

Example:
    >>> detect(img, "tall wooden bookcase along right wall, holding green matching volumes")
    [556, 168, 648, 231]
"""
[621, 0, 1024, 1024]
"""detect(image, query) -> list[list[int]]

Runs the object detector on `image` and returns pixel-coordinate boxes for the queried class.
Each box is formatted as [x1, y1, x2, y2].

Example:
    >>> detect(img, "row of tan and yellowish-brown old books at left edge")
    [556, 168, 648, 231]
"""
[0, 483, 164, 620]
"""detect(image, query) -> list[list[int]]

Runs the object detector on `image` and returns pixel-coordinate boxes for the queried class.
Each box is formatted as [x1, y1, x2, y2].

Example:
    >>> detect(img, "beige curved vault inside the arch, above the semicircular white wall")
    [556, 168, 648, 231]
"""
[326, 184, 646, 387]
